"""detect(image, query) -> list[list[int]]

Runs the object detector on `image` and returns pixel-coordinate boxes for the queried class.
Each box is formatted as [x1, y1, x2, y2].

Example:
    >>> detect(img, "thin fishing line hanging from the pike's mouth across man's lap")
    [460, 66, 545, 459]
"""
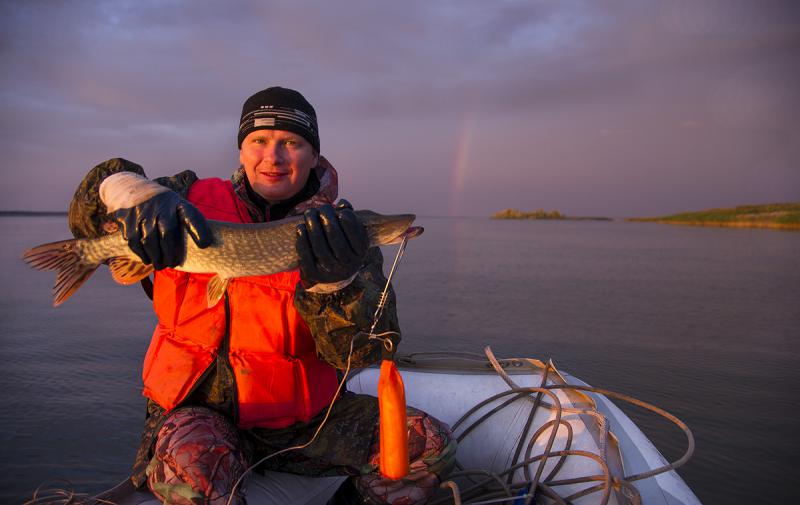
[226, 232, 412, 505]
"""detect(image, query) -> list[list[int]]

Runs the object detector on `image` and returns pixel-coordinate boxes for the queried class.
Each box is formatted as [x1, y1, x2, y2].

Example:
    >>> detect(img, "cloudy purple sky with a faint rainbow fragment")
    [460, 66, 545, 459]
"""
[0, 0, 800, 216]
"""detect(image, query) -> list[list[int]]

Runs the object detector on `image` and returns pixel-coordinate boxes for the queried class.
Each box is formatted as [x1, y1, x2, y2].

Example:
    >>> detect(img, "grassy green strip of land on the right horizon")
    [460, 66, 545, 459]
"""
[628, 203, 800, 231]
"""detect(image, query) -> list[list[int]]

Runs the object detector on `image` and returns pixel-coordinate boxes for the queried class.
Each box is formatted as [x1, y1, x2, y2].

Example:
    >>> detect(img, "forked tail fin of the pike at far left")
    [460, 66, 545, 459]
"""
[22, 239, 100, 307]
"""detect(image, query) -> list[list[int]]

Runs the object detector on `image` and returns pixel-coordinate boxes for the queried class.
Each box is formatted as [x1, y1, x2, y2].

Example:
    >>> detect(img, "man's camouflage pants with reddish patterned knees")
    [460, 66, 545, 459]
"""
[147, 394, 456, 505]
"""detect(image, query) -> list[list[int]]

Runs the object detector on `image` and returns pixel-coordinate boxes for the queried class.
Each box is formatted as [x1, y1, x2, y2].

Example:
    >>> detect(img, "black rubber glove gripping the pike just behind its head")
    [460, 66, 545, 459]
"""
[295, 200, 369, 287]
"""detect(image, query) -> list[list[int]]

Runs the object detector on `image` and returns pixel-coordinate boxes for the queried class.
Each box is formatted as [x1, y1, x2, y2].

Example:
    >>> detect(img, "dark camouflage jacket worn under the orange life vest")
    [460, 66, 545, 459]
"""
[68, 157, 400, 486]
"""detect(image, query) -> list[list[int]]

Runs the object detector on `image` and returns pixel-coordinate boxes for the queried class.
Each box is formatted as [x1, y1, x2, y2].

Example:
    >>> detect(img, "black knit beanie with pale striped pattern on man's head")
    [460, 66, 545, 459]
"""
[238, 86, 319, 152]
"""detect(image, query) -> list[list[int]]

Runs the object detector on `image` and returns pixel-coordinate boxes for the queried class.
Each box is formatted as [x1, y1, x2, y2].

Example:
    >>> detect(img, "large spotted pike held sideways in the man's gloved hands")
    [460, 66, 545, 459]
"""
[22, 210, 422, 307]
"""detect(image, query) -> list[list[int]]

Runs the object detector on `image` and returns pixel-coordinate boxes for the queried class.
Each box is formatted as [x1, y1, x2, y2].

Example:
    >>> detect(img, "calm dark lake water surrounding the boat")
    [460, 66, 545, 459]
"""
[0, 218, 800, 504]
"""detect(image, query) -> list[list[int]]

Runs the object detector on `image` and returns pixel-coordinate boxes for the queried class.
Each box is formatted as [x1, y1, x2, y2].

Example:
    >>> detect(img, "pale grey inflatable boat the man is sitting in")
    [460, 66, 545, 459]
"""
[87, 348, 700, 505]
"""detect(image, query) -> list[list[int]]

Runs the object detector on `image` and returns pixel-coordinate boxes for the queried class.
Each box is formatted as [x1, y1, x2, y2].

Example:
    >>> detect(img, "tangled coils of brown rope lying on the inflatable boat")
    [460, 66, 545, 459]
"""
[432, 346, 695, 505]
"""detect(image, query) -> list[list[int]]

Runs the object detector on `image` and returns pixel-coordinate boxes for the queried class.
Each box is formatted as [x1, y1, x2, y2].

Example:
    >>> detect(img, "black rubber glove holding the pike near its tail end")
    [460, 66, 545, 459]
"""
[114, 191, 214, 270]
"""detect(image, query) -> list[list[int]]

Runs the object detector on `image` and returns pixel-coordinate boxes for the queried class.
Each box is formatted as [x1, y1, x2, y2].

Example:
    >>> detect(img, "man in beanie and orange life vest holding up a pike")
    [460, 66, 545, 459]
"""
[69, 87, 455, 504]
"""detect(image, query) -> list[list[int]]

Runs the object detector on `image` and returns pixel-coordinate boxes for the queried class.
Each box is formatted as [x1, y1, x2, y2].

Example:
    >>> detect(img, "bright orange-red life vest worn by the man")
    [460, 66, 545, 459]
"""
[142, 179, 337, 428]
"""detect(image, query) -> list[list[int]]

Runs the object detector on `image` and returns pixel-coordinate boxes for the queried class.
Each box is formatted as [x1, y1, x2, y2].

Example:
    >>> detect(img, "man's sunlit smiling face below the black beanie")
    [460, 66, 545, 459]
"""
[239, 130, 319, 203]
